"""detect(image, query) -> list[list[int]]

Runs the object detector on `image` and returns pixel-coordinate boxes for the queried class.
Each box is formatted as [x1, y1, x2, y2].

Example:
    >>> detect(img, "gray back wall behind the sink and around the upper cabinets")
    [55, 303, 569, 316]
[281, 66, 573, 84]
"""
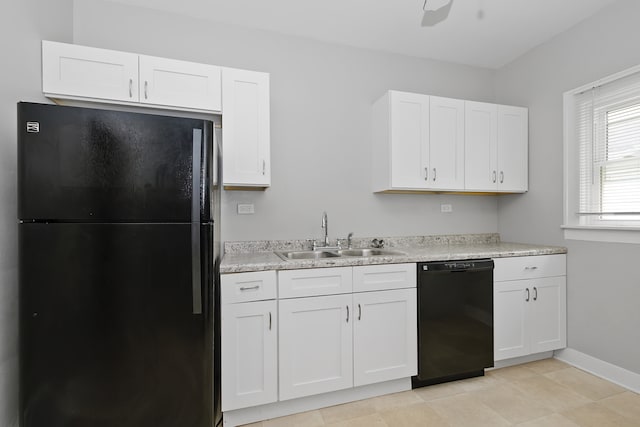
[74, 0, 497, 244]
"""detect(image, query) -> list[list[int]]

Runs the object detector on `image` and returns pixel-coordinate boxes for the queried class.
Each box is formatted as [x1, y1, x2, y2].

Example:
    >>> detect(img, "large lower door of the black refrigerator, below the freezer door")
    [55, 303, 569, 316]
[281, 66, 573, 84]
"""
[19, 224, 214, 427]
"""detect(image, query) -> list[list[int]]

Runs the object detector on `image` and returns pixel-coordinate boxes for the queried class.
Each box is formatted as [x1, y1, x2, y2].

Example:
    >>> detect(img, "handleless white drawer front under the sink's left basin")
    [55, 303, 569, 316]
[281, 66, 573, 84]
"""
[278, 267, 353, 298]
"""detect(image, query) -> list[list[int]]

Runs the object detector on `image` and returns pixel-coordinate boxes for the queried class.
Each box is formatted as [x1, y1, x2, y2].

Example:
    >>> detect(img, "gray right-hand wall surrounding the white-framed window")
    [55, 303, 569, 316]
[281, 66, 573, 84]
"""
[496, 0, 640, 373]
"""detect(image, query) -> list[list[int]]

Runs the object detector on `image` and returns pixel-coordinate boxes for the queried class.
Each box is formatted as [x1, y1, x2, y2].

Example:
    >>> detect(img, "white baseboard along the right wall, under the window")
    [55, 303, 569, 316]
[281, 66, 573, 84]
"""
[554, 348, 640, 393]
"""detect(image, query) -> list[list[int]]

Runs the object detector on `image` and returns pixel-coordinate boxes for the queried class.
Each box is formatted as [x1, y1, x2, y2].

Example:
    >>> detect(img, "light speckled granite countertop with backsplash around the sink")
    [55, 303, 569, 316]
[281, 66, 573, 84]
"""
[220, 234, 567, 274]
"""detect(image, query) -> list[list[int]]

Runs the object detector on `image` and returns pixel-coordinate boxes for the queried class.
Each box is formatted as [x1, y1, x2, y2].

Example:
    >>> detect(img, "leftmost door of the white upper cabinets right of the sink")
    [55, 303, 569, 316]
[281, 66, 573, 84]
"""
[388, 92, 429, 189]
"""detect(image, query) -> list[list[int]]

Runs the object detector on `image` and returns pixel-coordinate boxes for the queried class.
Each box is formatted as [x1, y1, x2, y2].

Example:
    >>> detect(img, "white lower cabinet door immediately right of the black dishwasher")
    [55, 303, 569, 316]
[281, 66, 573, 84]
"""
[493, 280, 532, 360]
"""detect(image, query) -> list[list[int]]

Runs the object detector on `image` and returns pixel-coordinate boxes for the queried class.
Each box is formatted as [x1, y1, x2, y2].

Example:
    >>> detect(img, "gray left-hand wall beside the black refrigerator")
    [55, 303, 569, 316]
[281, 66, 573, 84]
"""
[0, 0, 73, 426]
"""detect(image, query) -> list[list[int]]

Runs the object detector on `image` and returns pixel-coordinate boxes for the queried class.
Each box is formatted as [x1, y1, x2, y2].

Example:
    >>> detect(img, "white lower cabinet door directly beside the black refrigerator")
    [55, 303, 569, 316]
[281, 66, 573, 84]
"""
[222, 301, 278, 411]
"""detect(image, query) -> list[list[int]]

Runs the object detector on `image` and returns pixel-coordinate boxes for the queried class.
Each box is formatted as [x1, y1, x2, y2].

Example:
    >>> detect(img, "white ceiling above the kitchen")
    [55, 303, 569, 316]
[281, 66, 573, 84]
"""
[106, 0, 616, 69]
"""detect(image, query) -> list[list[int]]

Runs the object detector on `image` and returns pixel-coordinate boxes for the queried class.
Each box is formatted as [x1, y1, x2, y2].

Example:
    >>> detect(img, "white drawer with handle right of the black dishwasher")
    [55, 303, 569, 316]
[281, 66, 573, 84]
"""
[493, 254, 567, 282]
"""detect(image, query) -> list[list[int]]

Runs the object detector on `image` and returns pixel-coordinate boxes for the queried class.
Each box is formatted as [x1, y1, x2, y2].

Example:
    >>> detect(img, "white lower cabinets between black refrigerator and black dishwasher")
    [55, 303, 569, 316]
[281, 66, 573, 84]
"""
[221, 263, 417, 412]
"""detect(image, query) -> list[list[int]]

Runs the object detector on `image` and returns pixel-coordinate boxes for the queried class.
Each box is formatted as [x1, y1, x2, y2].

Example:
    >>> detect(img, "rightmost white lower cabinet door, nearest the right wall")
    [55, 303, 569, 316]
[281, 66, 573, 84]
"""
[530, 276, 567, 353]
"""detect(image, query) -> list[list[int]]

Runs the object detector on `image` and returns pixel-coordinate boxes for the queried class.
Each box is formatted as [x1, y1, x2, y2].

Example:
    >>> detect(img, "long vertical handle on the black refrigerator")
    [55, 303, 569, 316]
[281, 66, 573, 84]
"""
[191, 129, 202, 314]
